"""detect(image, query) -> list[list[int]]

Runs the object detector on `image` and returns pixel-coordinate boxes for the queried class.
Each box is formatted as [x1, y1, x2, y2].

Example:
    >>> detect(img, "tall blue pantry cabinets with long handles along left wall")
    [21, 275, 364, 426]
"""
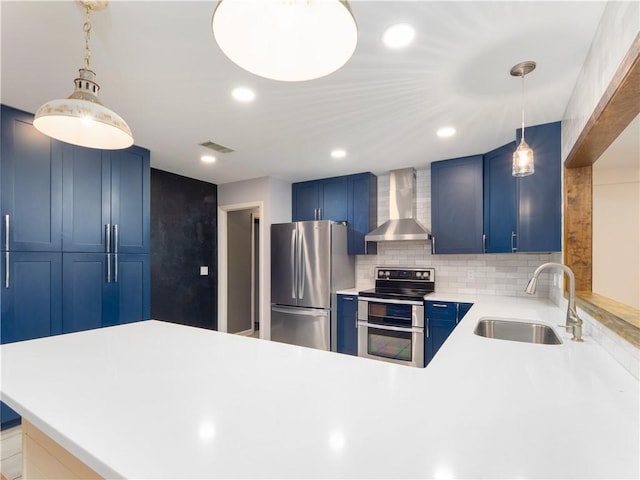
[0, 105, 150, 428]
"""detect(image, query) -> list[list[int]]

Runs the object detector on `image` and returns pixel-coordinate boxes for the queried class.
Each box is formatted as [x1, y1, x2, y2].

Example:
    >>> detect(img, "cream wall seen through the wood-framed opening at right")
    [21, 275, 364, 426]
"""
[592, 161, 640, 309]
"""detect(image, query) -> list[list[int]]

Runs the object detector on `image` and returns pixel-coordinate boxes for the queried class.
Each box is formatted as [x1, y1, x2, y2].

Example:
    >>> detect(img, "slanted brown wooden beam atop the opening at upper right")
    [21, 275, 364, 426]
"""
[564, 34, 640, 168]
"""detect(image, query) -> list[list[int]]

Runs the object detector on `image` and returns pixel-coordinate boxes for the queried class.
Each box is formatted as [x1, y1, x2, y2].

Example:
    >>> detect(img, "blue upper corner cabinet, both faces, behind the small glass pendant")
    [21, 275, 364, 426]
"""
[484, 122, 562, 253]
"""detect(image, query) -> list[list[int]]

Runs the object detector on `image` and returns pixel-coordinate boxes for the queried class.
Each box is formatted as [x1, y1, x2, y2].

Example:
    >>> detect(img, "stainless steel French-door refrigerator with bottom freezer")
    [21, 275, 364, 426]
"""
[271, 221, 355, 350]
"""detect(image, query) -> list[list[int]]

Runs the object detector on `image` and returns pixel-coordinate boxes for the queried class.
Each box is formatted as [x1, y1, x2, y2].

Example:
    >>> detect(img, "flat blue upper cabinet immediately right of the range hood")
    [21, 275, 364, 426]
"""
[431, 155, 483, 254]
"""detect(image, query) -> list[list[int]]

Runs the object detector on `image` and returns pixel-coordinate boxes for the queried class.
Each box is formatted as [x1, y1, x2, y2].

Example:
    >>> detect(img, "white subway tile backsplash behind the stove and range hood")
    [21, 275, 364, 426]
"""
[356, 168, 561, 297]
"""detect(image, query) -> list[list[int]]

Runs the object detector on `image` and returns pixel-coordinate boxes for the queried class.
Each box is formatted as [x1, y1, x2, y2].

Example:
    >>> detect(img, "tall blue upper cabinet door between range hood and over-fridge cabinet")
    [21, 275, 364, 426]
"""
[347, 173, 378, 255]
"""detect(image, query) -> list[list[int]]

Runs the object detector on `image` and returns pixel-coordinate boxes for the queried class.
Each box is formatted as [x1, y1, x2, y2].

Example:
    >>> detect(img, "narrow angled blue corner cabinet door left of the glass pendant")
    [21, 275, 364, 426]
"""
[484, 142, 517, 253]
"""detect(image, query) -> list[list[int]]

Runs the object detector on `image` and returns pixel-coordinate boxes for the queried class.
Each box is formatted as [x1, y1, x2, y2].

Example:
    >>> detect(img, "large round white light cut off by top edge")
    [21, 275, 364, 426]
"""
[211, 0, 358, 82]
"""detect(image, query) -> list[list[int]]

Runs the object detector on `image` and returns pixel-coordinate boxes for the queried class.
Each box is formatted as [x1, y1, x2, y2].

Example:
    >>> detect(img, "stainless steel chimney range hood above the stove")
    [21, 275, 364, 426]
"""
[364, 168, 431, 242]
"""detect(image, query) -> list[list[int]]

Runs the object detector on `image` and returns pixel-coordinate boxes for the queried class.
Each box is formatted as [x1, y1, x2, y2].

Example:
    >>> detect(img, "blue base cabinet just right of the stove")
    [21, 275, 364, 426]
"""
[424, 301, 472, 366]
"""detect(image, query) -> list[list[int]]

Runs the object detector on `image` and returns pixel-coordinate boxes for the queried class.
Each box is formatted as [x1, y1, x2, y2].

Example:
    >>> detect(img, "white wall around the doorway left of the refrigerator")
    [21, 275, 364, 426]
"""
[218, 177, 291, 340]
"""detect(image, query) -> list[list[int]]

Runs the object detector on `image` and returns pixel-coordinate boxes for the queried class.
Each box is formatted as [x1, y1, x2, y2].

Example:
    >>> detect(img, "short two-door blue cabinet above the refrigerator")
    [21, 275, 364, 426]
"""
[292, 177, 348, 222]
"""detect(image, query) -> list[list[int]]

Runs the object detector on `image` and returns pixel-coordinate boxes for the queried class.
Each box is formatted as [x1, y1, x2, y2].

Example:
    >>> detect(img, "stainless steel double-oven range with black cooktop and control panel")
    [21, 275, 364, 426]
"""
[358, 267, 435, 367]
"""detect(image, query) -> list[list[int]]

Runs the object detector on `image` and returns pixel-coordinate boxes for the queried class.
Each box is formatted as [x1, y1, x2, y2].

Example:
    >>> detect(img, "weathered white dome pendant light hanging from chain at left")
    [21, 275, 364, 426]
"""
[33, 0, 133, 150]
